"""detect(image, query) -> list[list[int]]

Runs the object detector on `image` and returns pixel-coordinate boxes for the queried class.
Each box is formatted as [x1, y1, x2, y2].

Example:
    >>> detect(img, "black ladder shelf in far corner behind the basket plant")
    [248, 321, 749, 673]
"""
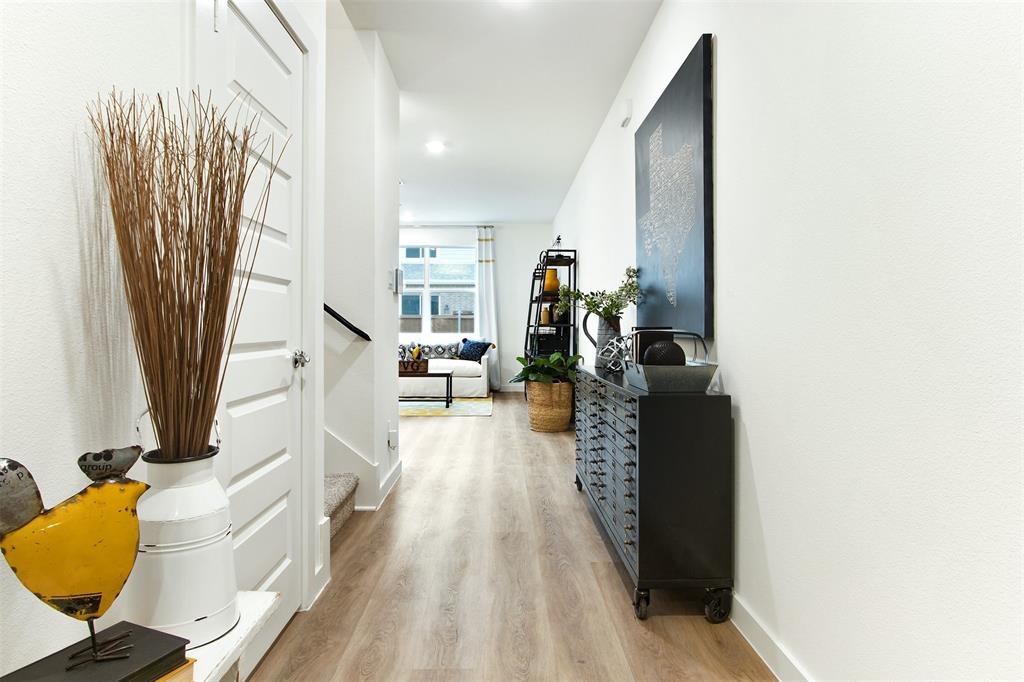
[523, 249, 580, 357]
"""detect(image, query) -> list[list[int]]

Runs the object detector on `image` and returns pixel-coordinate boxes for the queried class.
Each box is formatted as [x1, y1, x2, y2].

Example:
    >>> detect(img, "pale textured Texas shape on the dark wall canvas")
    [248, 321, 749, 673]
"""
[639, 125, 697, 307]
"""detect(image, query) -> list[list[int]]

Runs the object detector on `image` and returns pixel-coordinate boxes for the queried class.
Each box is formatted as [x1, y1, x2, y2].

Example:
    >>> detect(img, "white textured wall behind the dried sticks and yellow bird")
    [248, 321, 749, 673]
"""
[0, 2, 190, 673]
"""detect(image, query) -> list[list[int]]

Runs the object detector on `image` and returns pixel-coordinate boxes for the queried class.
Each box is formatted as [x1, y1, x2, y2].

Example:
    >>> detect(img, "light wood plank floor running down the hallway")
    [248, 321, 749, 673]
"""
[252, 394, 773, 682]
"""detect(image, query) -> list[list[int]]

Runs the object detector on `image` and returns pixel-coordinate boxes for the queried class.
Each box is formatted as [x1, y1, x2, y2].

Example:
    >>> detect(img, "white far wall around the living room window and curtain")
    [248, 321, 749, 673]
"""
[399, 223, 551, 391]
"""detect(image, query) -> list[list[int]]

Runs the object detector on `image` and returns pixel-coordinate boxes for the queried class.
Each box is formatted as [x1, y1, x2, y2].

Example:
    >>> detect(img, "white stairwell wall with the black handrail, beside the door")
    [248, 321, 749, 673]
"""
[325, 10, 401, 508]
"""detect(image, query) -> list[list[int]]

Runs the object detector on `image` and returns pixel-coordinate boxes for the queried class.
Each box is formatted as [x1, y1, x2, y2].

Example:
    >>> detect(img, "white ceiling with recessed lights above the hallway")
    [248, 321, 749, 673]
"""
[342, 0, 660, 224]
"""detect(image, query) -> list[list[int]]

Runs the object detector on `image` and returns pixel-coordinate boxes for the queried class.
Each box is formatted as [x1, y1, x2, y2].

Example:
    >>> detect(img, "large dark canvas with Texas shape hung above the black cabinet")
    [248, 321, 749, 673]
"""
[634, 34, 715, 338]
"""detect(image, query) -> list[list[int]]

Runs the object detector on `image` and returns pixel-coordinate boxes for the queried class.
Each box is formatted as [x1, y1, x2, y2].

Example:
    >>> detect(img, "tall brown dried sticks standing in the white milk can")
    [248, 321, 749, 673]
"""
[89, 91, 280, 460]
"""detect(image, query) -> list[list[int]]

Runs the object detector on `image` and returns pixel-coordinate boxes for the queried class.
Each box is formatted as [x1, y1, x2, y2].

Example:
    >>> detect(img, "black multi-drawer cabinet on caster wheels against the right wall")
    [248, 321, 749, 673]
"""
[575, 369, 733, 623]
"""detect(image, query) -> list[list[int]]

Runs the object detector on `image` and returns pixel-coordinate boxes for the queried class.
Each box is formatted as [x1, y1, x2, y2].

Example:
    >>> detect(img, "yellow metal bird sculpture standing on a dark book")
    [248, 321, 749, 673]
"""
[0, 445, 150, 670]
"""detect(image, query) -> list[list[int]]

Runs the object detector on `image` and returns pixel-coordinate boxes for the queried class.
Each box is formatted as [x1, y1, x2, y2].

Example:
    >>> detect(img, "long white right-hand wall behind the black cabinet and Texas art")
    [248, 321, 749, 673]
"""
[554, 2, 1024, 679]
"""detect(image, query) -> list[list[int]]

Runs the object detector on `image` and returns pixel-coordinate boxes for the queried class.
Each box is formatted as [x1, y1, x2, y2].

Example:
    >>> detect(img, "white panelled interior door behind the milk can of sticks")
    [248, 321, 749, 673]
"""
[197, 0, 304, 675]
